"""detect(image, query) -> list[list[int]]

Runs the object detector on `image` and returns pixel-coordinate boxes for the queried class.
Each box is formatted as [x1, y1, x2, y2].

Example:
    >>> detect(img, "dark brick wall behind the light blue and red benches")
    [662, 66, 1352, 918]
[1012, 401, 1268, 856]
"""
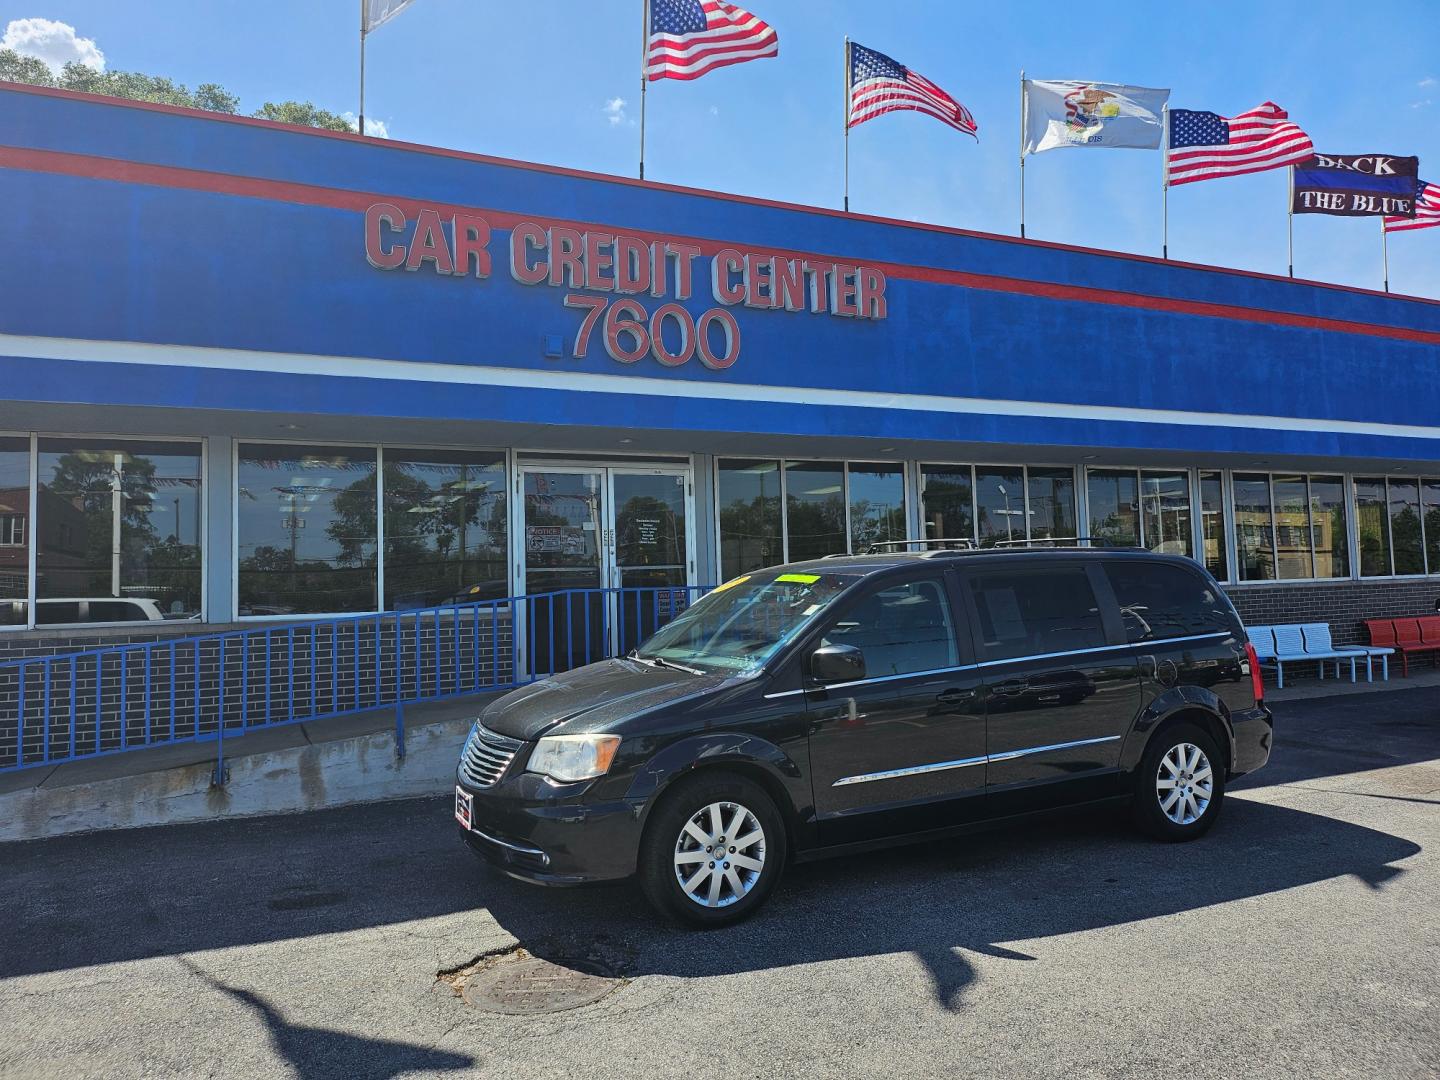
[1225, 577, 1440, 645]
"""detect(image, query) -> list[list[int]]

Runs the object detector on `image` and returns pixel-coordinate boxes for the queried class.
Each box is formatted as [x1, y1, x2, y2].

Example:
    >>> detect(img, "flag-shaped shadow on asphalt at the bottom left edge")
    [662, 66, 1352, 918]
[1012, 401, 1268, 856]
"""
[180, 956, 475, 1080]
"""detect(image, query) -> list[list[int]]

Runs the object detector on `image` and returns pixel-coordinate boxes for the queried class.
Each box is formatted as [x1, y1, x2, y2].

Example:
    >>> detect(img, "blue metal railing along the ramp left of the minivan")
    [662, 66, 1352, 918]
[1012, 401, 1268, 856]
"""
[0, 586, 711, 783]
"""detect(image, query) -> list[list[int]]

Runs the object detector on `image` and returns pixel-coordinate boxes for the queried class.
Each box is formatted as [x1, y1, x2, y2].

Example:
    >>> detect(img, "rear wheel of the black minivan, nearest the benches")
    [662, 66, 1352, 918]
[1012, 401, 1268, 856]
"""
[1135, 724, 1225, 840]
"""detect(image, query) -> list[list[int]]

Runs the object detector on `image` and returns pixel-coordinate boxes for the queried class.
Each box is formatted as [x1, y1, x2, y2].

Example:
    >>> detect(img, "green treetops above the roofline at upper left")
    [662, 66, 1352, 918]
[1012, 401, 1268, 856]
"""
[0, 49, 356, 131]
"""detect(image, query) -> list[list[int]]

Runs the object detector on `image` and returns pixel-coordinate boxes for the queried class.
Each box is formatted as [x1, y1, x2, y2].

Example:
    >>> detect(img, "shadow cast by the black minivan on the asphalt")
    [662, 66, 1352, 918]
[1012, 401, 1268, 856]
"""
[487, 799, 1420, 1008]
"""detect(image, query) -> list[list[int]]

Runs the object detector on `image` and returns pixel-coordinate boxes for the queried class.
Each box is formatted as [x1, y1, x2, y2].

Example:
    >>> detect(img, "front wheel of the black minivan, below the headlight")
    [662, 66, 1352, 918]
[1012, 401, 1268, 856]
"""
[639, 772, 786, 926]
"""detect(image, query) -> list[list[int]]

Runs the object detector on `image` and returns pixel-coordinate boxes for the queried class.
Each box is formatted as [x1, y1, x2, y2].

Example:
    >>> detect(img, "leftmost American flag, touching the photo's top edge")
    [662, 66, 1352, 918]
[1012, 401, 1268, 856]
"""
[645, 0, 780, 82]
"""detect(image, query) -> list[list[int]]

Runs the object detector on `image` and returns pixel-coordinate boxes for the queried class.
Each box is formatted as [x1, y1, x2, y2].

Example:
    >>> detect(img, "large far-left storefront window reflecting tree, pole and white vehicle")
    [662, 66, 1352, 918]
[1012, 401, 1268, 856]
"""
[34, 439, 203, 625]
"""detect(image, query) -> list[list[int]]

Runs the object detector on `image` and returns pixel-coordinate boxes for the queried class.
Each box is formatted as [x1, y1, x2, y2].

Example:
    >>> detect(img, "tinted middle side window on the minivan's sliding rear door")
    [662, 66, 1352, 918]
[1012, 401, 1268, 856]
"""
[971, 567, 1107, 660]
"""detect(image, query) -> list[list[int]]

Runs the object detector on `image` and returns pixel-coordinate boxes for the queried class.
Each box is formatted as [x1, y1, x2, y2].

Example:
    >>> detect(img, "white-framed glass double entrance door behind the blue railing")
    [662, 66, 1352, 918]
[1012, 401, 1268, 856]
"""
[517, 465, 694, 674]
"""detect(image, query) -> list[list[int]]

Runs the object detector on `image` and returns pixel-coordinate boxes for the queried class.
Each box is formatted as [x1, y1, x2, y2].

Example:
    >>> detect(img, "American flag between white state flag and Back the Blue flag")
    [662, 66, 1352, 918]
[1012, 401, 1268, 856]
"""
[1165, 101, 1315, 184]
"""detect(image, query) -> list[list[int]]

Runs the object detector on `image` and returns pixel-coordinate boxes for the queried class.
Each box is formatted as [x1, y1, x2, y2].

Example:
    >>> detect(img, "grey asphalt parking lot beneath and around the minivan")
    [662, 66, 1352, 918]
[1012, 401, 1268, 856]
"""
[0, 688, 1440, 1080]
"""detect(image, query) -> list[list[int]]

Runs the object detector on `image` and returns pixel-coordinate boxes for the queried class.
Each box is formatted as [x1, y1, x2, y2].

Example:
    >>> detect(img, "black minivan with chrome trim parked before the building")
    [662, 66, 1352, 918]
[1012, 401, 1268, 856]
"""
[455, 547, 1272, 924]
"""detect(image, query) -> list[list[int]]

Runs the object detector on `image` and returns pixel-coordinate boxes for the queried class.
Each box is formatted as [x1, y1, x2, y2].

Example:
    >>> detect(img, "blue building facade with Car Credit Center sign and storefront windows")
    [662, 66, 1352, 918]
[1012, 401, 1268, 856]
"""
[0, 85, 1440, 655]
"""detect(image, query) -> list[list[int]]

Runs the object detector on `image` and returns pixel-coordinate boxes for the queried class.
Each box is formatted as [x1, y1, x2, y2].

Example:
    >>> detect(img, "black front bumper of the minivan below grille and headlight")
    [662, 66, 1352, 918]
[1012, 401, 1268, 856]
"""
[455, 770, 641, 886]
